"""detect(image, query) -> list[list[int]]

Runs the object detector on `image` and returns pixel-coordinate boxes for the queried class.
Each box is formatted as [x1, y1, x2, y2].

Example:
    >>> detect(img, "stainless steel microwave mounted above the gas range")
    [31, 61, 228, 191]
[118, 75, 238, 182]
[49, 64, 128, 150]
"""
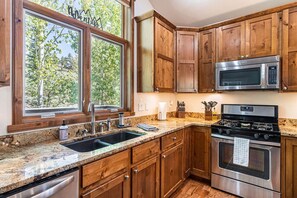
[215, 56, 280, 91]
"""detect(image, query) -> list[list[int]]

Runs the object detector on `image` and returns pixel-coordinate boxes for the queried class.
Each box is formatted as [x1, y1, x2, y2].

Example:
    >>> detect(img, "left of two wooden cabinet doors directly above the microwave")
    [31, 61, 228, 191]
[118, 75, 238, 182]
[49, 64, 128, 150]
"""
[216, 22, 245, 62]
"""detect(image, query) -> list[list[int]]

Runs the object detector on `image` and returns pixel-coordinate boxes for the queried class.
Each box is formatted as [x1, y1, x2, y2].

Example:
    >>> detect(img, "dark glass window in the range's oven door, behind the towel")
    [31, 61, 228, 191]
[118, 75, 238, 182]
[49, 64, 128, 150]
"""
[219, 142, 270, 180]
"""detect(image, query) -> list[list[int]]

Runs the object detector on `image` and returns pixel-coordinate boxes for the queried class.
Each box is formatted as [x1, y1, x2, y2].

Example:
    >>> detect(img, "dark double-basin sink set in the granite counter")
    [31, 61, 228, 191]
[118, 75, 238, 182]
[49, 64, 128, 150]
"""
[61, 131, 145, 152]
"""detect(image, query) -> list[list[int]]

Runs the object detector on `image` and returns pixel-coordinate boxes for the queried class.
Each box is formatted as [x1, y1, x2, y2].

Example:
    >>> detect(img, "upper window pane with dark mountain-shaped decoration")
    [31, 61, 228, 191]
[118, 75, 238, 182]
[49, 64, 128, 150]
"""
[30, 0, 123, 36]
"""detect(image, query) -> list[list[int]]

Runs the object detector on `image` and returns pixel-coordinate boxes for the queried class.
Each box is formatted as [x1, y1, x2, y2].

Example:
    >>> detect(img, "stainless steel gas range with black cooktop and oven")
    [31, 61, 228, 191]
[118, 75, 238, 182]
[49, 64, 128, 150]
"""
[211, 104, 281, 198]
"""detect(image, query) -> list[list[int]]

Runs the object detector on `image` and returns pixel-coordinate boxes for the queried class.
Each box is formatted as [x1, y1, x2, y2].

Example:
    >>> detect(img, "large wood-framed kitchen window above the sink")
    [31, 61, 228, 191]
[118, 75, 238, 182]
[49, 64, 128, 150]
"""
[8, 0, 134, 132]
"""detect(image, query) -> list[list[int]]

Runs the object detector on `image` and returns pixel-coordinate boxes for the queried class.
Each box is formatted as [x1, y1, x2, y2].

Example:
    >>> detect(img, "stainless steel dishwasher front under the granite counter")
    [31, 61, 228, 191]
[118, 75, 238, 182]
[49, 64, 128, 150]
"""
[0, 169, 79, 198]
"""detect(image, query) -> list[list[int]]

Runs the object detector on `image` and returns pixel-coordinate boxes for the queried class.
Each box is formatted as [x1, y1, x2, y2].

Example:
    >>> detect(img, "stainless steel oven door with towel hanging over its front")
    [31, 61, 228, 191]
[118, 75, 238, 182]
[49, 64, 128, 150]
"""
[211, 135, 280, 192]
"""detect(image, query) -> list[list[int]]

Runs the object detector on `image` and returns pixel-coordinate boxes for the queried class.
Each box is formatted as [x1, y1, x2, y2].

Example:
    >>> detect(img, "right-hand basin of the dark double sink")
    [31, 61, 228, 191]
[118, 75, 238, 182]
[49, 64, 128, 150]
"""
[100, 131, 144, 144]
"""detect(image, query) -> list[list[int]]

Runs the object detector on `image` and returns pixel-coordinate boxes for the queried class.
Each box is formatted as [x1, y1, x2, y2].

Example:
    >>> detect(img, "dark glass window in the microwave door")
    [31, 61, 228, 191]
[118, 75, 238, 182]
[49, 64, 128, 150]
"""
[220, 67, 261, 86]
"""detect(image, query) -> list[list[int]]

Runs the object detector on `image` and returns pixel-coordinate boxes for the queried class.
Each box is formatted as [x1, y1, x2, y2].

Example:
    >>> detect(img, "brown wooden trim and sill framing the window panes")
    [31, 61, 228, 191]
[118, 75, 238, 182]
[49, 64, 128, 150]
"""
[7, 0, 135, 133]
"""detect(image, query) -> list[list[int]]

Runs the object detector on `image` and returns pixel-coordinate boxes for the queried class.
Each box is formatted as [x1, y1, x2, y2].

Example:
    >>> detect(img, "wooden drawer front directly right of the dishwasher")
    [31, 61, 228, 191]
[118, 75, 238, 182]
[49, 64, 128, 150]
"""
[82, 150, 129, 188]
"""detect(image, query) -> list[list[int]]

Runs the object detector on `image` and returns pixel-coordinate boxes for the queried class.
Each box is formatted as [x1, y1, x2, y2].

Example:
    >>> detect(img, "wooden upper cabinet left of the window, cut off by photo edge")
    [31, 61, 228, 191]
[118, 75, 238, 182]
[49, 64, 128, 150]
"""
[0, 0, 10, 87]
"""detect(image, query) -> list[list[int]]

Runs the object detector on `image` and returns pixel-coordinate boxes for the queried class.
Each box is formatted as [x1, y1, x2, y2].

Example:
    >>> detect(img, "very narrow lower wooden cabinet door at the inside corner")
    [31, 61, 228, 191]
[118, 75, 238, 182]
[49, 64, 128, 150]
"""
[183, 127, 192, 179]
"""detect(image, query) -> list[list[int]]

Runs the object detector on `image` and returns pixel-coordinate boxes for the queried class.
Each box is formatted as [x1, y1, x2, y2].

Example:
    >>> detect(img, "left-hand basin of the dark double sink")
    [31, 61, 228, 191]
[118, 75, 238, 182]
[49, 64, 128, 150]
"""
[62, 138, 110, 152]
